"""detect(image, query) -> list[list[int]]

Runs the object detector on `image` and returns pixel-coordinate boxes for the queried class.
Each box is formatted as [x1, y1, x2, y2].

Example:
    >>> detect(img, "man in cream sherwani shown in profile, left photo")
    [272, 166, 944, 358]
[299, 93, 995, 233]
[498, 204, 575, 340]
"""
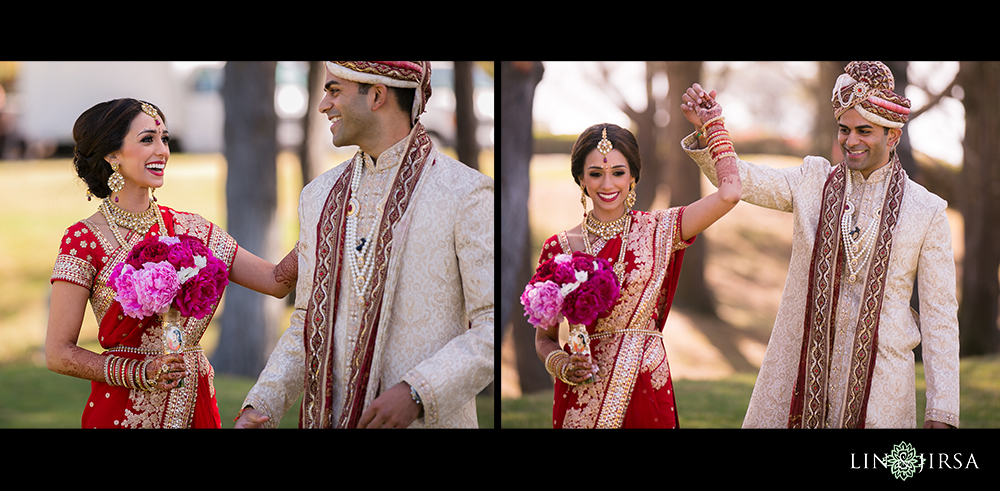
[236, 61, 494, 428]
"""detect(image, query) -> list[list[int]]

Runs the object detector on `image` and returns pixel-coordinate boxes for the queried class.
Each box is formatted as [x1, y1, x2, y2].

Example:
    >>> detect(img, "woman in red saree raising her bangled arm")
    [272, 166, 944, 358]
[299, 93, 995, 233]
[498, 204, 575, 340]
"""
[535, 90, 741, 428]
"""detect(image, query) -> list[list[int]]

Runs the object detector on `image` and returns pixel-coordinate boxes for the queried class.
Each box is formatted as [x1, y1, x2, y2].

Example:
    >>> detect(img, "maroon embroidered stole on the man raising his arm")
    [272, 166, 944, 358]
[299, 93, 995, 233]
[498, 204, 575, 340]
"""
[788, 154, 906, 428]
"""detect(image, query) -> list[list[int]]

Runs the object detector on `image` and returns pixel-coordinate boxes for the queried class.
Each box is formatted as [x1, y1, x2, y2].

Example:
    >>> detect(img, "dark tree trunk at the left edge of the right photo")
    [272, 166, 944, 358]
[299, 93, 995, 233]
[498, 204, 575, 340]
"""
[499, 61, 552, 393]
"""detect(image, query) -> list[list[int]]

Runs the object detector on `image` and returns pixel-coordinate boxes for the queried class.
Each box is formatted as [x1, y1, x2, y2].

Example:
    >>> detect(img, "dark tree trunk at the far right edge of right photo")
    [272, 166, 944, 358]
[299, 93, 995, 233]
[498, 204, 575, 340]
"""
[958, 62, 1000, 356]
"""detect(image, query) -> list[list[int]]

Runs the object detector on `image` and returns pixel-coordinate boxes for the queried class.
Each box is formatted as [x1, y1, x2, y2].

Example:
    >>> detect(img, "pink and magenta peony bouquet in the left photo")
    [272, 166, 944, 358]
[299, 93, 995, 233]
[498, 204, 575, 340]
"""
[108, 235, 229, 319]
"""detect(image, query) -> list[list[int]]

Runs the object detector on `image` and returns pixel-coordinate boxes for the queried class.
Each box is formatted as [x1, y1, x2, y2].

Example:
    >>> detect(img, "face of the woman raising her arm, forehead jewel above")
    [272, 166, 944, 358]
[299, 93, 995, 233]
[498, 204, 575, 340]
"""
[581, 149, 632, 221]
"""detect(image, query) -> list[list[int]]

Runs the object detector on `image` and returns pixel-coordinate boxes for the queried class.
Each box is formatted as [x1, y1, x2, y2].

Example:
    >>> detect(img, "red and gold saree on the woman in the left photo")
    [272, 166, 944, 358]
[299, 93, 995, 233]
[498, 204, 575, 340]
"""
[51, 206, 237, 428]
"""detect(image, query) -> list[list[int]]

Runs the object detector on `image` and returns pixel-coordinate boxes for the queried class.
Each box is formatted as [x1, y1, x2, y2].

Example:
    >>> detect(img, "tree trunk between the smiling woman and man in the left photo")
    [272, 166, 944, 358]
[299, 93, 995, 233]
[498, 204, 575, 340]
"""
[212, 62, 281, 377]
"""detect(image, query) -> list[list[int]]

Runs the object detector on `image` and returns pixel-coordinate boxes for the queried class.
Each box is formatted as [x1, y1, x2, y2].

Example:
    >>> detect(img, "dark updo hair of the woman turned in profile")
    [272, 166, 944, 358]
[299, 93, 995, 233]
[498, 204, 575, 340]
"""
[73, 99, 167, 199]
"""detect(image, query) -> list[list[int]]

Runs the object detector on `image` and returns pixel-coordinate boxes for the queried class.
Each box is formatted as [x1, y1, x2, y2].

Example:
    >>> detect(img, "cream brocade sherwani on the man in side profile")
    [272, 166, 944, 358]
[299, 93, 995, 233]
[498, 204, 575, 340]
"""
[244, 134, 494, 428]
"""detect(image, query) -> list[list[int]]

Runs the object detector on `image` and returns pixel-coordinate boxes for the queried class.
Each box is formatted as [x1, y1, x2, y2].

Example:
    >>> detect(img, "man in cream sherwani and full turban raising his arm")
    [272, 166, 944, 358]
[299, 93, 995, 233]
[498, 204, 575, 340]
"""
[683, 62, 959, 428]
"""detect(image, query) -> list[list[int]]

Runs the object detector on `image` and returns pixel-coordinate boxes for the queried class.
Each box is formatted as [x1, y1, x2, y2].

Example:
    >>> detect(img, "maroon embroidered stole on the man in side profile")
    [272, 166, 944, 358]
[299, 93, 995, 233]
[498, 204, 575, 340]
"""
[299, 123, 431, 428]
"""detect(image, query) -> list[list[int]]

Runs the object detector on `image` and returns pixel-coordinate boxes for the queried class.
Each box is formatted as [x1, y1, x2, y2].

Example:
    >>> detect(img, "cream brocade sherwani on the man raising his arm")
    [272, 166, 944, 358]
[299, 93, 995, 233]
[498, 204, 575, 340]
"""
[682, 135, 959, 428]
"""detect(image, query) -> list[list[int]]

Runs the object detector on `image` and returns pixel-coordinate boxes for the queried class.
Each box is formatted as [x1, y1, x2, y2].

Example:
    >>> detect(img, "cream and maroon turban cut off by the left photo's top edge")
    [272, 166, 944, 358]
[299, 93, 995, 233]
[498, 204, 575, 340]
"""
[326, 61, 431, 124]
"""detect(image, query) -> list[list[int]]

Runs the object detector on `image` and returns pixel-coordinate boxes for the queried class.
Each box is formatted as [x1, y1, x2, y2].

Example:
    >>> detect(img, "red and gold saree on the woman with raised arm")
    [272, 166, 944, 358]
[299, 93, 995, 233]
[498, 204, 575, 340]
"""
[539, 207, 694, 428]
